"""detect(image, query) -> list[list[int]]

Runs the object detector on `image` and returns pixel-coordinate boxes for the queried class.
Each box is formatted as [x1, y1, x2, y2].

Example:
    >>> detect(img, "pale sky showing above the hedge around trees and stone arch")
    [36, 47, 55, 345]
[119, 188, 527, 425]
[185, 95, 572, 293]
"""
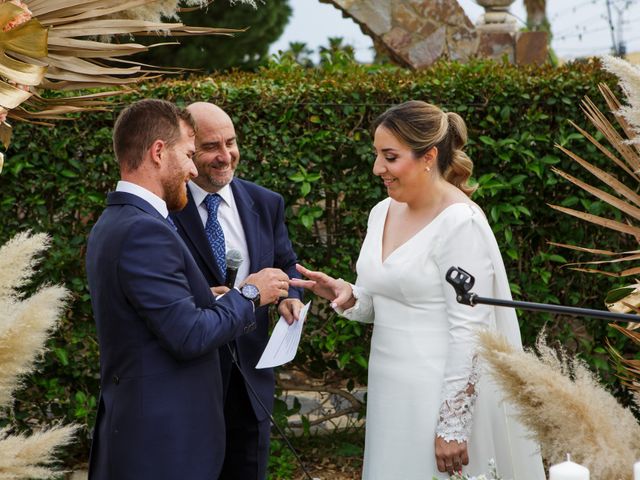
[271, 0, 640, 62]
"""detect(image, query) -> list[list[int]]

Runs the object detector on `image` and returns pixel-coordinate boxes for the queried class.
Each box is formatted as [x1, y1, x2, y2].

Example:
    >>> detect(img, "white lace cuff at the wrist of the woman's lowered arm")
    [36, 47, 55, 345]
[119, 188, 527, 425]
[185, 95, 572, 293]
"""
[436, 357, 478, 442]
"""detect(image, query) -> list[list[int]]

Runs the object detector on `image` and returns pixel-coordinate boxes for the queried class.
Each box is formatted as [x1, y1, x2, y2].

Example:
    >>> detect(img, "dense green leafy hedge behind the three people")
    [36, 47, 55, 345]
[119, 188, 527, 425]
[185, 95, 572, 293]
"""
[0, 59, 633, 463]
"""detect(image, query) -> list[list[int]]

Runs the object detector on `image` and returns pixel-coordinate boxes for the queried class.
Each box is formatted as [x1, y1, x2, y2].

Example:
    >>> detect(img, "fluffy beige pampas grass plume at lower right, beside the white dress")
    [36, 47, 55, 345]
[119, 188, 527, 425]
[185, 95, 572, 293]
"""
[480, 331, 640, 480]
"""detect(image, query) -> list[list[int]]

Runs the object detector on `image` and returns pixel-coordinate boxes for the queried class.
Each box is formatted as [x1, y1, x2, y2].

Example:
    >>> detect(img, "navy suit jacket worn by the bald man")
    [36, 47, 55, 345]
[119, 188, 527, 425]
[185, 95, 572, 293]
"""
[171, 178, 302, 421]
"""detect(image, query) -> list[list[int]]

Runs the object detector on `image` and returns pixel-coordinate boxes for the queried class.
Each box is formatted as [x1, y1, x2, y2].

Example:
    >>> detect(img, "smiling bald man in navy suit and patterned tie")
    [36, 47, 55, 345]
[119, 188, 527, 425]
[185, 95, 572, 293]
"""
[172, 102, 302, 480]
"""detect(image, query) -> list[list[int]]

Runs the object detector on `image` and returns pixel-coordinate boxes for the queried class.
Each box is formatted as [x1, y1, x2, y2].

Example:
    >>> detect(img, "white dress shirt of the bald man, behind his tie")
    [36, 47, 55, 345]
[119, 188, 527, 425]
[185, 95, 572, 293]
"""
[188, 182, 251, 287]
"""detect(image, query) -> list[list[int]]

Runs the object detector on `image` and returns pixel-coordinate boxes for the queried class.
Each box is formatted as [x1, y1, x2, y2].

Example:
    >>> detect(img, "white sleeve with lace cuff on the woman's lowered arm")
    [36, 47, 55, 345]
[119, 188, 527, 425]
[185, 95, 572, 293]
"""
[436, 211, 494, 442]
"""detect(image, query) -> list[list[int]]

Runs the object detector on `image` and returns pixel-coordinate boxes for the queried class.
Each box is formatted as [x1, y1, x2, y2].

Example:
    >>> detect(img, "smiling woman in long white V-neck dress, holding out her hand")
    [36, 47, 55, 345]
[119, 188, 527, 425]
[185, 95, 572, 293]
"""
[290, 101, 545, 480]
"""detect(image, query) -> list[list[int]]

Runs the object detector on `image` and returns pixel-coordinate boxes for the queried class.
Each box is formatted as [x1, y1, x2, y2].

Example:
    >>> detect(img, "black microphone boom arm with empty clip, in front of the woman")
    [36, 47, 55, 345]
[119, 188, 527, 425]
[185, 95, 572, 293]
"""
[445, 267, 640, 322]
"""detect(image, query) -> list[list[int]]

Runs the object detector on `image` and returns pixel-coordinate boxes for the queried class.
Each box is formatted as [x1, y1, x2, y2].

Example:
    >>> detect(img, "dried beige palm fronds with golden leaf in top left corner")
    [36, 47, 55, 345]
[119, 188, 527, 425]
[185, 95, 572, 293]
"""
[0, 0, 255, 150]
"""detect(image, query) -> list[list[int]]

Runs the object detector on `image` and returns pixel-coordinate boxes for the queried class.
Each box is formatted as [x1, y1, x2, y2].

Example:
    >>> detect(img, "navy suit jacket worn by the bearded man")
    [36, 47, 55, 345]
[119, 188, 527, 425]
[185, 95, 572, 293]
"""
[86, 192, 255, 480]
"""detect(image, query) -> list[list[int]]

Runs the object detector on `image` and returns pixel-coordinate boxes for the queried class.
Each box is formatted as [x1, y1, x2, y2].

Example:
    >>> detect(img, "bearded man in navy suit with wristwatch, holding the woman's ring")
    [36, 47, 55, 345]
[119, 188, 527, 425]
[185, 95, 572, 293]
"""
[86, 100, 288, 480]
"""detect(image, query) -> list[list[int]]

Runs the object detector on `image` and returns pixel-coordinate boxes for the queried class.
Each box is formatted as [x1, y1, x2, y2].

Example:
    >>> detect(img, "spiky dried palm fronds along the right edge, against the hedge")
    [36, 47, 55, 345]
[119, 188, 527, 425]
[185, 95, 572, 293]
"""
[550, 57, 640, 390]
